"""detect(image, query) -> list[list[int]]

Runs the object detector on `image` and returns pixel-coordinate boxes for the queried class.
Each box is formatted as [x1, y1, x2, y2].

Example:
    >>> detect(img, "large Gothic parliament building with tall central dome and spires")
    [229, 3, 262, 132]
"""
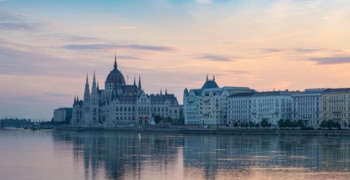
[71, 57, 181, 127]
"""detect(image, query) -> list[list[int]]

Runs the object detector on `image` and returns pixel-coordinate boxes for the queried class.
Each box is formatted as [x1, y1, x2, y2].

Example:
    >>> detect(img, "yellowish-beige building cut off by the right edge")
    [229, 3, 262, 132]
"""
[322, 88, 350, 127]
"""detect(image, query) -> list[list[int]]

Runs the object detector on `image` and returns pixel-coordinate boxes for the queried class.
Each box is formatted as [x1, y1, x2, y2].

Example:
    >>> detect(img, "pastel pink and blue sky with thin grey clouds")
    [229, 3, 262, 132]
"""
[0, 0, 350, 120]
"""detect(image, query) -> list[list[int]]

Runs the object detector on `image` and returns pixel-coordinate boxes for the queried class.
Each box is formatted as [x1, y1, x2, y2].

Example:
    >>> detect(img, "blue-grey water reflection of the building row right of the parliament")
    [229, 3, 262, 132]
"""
[184, 135, 334, 176]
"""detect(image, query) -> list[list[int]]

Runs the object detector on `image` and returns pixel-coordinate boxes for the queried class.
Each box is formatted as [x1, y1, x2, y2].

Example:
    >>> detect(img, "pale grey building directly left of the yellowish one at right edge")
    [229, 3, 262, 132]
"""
[292, 88, 325, 127]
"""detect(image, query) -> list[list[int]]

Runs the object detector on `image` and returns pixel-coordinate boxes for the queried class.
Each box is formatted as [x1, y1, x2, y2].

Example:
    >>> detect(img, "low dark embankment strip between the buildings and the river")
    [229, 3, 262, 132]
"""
[55, 126, 350, 137]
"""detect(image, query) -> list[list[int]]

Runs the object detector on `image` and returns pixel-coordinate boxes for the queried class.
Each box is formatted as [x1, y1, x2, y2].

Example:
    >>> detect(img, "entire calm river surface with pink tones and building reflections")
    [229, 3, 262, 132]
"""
[0, 129, 350, 180]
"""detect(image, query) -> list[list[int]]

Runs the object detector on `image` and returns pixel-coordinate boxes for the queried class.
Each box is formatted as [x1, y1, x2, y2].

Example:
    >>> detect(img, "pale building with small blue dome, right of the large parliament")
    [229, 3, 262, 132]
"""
[183, 76, 254, 126]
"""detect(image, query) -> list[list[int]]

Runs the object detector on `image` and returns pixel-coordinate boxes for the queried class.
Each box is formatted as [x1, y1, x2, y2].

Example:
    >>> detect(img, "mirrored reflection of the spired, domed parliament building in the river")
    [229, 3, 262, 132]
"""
[52, 132, 183, 179]
